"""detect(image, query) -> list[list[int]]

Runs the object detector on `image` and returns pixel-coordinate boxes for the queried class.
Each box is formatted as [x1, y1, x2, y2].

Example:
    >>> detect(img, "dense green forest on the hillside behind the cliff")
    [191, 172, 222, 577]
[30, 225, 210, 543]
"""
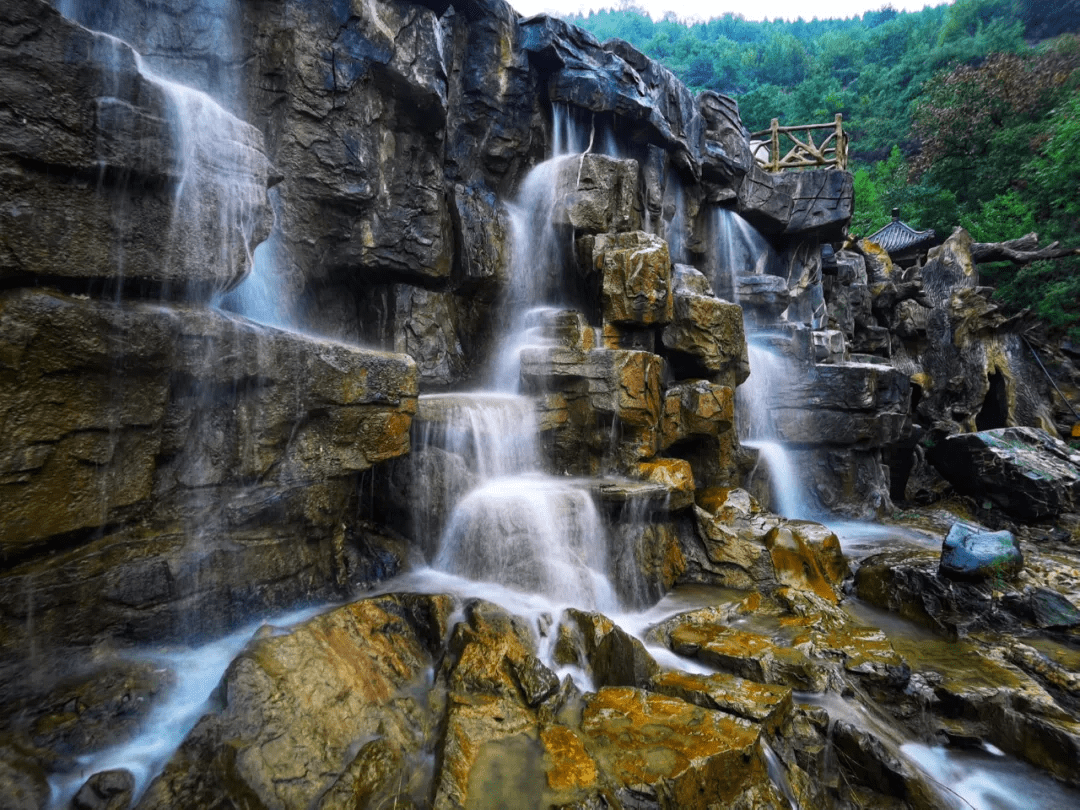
[568, 0, 1080, 340]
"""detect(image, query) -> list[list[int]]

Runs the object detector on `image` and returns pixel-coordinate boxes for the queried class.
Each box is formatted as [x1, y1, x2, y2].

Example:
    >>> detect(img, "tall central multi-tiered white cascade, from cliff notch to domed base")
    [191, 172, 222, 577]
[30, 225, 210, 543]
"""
[419, 107, 618, 610]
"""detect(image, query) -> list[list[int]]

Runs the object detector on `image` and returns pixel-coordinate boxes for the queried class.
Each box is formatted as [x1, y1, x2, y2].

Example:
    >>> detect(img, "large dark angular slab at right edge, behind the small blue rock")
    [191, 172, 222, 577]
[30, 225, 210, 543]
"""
[930, 428, 1080, 521]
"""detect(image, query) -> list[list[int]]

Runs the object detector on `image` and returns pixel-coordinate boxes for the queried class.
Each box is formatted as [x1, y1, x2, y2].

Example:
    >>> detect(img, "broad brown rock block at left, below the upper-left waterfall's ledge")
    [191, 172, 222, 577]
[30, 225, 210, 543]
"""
[0, 289, 417, 656]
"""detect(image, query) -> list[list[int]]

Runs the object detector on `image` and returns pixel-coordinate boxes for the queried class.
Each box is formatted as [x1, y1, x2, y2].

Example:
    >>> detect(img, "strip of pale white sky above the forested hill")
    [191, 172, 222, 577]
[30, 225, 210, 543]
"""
[510, 0, 951, 19]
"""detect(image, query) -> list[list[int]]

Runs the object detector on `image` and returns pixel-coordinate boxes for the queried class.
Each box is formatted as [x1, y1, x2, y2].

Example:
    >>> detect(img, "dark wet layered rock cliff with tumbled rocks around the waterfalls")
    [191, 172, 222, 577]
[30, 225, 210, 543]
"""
[0, 0, 1080, 808]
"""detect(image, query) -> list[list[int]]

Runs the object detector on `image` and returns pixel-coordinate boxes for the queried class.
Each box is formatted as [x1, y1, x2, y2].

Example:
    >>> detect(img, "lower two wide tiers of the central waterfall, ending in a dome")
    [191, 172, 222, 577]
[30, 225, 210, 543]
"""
[413, 392, 617, 609]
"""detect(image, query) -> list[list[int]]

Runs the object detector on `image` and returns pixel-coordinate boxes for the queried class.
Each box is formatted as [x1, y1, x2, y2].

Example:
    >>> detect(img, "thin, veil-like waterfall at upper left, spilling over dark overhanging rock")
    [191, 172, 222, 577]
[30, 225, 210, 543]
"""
[56, 0, 282, 327]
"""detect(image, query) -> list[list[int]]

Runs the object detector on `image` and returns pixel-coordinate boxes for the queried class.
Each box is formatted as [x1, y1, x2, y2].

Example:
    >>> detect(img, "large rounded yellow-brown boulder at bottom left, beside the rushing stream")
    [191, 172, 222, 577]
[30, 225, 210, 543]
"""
[138, 594, 455, 810]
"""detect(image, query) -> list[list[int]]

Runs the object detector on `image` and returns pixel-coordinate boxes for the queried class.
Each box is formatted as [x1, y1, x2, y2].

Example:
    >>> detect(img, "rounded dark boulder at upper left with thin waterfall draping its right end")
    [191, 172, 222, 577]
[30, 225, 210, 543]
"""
[0, 0, 273, 300]
